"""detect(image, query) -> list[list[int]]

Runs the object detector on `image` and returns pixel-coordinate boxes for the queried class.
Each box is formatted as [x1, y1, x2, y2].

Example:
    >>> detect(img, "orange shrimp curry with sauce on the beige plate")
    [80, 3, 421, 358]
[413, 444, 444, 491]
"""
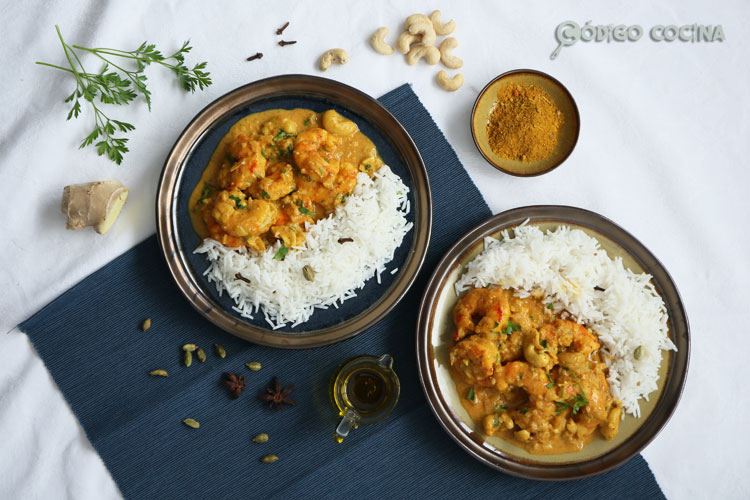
[449, 288, 621, 454]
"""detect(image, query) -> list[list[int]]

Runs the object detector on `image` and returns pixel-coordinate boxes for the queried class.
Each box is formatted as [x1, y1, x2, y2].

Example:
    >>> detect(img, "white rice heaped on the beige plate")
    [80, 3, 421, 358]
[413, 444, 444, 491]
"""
[455, 221, 676, 417]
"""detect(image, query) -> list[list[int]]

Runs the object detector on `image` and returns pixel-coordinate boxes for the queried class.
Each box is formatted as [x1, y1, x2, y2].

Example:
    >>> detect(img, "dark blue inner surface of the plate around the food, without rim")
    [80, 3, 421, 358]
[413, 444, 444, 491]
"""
[175, 95, 415, 333]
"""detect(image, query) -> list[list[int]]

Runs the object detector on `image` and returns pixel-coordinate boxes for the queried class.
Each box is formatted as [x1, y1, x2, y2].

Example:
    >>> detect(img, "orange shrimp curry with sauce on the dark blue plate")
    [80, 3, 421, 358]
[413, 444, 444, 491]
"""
[189, 109, 383, 252]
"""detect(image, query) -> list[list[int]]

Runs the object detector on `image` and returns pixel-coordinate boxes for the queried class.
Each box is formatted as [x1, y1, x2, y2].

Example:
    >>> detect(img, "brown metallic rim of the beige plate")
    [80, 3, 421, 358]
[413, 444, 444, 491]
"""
[415, 205, 690, 481]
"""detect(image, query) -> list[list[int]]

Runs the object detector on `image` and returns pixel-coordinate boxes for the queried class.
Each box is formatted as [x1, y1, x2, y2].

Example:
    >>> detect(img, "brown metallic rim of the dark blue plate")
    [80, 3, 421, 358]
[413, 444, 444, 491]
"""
[155, 74, 432, 349]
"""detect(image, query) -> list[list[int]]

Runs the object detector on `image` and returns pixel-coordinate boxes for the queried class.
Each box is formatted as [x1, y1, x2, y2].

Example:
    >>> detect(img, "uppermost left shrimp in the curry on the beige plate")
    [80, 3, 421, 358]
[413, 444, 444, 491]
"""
[453, 288, 510, 340]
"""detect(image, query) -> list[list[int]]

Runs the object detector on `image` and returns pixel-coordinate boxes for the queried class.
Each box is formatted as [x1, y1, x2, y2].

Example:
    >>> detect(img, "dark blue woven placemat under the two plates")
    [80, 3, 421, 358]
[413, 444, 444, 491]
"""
[20, 85, 664, 499]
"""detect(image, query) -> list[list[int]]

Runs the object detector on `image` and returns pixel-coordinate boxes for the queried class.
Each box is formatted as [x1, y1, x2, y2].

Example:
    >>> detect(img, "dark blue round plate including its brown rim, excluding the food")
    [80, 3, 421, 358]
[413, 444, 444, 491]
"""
[156, 75, 432, 349]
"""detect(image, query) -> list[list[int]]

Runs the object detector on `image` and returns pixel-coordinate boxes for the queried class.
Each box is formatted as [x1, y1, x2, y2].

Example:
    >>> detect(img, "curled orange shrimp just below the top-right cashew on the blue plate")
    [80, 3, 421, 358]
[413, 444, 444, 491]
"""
[294, 128, 341, 185]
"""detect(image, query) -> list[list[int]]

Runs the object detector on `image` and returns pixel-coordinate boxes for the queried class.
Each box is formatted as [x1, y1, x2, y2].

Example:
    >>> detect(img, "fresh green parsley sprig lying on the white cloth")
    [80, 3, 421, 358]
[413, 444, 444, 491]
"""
[36, 26, 212, 165]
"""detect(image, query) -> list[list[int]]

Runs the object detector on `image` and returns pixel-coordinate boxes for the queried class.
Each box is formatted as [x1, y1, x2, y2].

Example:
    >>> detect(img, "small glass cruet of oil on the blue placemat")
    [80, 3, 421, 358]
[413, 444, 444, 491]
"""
[331, 354, 401, 443]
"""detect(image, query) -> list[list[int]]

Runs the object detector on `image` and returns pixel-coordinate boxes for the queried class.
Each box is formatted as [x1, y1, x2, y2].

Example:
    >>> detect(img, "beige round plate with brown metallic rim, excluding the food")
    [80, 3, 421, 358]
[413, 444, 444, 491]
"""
[416, 206, 690, 480]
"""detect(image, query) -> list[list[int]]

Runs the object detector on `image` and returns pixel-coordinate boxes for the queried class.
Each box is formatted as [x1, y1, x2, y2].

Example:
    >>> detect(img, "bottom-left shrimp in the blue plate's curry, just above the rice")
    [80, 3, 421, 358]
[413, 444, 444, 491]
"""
[211, 191, 278, 238]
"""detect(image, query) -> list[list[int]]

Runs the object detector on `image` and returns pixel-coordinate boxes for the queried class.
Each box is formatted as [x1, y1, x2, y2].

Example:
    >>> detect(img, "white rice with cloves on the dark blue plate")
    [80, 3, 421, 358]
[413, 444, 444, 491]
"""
[195, 166, 412, 330]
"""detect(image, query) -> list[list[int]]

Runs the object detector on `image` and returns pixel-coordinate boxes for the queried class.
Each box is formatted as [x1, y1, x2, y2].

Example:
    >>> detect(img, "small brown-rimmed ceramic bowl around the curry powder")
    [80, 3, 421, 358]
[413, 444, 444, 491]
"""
[471, 69, 581, 177]
